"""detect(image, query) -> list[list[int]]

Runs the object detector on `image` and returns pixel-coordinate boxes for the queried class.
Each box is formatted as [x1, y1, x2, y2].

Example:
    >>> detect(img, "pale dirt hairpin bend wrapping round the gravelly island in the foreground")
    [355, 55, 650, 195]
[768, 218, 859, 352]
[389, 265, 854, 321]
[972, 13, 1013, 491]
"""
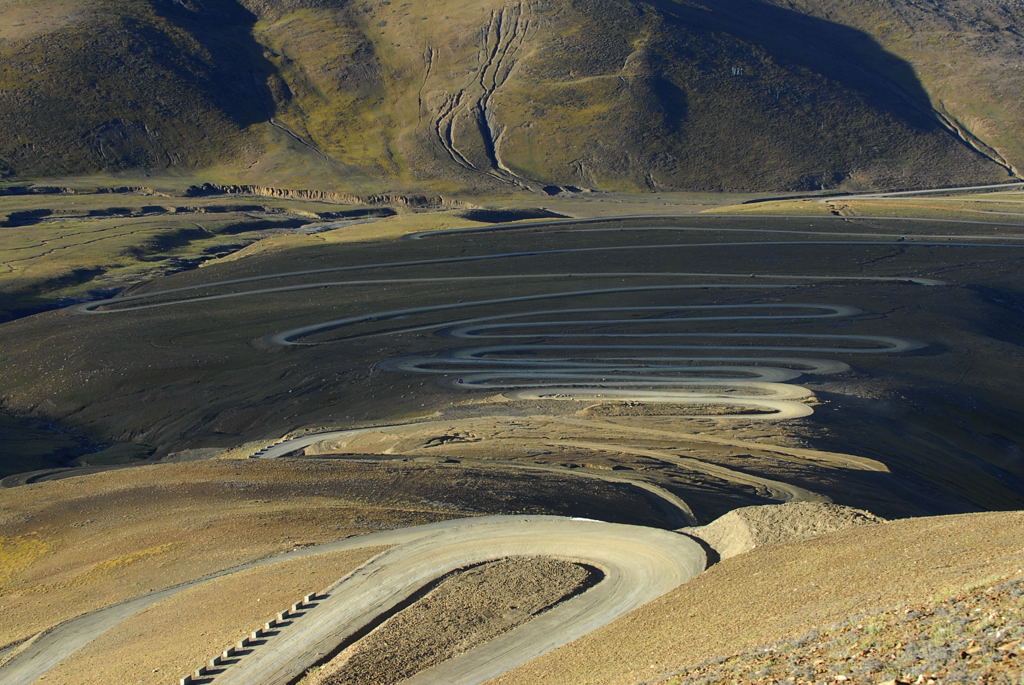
[208, 516, 707, 685]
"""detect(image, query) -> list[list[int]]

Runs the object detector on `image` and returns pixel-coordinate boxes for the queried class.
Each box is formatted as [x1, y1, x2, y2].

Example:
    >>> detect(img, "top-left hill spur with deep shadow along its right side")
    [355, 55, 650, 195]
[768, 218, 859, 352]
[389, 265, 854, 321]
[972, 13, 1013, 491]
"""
[0, 0, 273, 176]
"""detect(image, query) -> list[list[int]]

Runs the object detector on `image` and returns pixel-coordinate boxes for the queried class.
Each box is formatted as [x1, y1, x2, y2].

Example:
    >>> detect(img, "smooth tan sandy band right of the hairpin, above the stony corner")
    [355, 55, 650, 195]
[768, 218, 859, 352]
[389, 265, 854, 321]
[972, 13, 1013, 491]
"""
[495, 512, 1024, 685]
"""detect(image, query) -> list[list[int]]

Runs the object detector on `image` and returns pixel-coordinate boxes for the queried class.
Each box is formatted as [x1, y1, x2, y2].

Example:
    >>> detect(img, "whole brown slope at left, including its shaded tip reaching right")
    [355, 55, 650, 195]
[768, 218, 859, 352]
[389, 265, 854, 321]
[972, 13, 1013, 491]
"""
[0, 460, 660, 645]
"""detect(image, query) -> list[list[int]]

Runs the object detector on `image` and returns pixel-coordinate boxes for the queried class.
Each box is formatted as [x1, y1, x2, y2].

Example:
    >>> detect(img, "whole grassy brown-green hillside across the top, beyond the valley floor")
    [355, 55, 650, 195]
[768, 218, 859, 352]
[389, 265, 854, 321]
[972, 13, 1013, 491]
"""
[0, 0, 1021, 191]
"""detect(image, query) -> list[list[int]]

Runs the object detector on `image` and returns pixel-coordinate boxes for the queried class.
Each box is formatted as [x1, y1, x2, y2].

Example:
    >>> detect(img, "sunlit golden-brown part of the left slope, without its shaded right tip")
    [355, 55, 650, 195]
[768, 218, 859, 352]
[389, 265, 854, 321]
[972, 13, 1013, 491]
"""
[0, 460, 468, 644]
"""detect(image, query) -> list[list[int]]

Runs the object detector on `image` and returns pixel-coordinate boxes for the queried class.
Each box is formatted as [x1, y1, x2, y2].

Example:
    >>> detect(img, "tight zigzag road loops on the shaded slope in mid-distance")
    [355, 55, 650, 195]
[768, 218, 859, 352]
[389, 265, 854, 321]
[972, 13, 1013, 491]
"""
[79, 228, 974, 420]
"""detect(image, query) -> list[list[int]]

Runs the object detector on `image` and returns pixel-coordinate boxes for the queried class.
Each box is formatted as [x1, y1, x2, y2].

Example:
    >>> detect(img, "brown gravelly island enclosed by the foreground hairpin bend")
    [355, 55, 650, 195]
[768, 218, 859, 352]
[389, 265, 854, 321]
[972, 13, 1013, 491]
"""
[302, 557, 593, 685]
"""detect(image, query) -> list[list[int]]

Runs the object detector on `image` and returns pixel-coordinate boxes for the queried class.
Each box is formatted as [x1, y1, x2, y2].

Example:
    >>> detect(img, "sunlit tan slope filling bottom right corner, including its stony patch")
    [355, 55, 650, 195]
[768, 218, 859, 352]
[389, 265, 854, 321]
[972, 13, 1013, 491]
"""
[494, 512, 1024, 685]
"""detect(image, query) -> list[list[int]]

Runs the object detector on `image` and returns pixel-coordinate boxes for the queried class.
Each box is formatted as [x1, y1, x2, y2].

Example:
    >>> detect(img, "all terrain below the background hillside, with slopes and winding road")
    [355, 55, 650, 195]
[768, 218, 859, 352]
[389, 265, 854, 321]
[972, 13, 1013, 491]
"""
[0, 179, 1024, 684]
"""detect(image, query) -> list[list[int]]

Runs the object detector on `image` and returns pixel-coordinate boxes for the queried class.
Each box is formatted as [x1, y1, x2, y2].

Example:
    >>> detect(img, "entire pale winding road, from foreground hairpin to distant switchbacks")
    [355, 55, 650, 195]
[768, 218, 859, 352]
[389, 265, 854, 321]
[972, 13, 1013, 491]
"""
[22, 217, 1024, 685]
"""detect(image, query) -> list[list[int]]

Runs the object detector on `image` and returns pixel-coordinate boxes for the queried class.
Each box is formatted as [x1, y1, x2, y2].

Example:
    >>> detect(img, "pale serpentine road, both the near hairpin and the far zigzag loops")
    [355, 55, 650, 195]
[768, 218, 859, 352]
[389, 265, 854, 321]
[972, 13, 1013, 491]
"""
[41, 217, 1024, 685]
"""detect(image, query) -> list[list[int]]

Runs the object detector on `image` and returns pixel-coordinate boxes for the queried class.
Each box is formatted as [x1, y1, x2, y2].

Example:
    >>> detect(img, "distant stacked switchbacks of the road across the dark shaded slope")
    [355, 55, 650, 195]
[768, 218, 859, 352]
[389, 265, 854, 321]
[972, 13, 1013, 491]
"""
[79, 222, 1024, 421]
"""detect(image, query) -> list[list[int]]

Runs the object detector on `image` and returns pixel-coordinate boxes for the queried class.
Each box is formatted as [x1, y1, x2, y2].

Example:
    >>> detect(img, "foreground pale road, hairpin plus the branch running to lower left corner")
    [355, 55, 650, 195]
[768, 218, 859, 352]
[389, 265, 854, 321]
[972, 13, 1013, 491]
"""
[0, 516, 707, 685]
